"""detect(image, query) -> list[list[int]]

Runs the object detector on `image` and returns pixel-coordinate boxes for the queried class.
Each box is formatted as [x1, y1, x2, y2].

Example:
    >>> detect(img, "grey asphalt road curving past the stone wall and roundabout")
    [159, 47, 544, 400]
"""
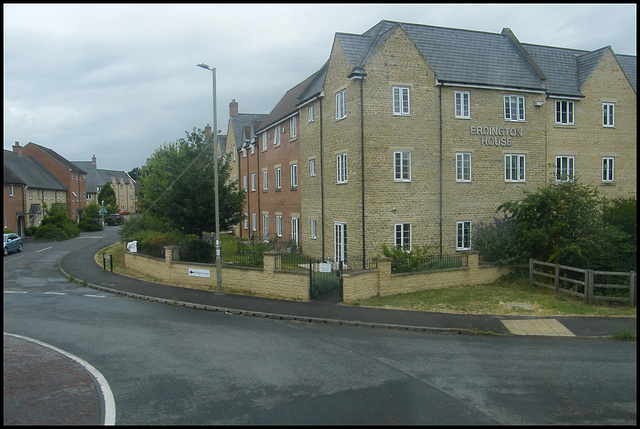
[4, 227, 637, 425]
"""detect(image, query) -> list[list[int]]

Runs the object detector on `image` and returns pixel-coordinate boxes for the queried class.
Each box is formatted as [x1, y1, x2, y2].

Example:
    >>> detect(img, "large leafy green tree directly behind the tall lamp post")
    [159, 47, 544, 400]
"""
[139, 128, 244, 236]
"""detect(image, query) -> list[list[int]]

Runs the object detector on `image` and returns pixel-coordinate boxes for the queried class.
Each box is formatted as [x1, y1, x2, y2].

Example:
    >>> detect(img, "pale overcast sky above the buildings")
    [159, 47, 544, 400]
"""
[3, 3, 637, 171]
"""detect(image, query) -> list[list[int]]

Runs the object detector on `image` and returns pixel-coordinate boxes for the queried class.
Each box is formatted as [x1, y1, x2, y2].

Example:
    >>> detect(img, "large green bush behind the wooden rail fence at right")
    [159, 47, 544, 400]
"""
[484, 180, 637, 270]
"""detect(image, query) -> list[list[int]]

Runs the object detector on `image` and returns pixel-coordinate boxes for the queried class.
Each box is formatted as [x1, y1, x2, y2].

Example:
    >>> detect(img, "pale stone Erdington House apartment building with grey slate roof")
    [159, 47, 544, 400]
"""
[230, 21, 637, 265]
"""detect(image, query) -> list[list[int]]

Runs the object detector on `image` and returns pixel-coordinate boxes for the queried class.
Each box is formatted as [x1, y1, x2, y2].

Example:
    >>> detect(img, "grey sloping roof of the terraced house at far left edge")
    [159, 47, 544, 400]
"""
[4, 150, 67, 191]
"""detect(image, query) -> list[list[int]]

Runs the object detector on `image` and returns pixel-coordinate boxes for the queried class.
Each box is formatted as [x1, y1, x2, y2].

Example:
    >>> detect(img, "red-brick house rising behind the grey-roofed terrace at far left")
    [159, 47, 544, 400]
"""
[19, 142, 87, 221]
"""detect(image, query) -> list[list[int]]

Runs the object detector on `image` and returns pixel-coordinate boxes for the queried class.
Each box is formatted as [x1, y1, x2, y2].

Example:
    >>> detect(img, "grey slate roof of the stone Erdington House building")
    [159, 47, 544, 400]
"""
[336, 20, 636, 97]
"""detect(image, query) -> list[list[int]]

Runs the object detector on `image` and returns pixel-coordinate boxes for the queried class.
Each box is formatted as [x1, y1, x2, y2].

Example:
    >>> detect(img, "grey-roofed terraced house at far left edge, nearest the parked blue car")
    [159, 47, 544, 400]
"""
[3, 144, 67, 236]
